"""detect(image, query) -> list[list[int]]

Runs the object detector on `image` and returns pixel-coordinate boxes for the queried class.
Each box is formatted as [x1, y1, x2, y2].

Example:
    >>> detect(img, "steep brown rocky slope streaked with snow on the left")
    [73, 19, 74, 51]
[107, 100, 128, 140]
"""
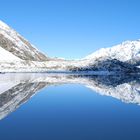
[0, 21, 49, 61]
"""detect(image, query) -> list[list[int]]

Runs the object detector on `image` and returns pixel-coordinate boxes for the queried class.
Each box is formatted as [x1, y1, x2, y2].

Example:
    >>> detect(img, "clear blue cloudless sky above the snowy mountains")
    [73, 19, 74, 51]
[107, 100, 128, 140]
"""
[0, 0, 140, 59]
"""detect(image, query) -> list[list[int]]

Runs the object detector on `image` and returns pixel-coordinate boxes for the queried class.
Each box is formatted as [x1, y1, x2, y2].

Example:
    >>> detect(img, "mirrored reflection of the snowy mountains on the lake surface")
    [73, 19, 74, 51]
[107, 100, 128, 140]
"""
[0, 73, 140, 119]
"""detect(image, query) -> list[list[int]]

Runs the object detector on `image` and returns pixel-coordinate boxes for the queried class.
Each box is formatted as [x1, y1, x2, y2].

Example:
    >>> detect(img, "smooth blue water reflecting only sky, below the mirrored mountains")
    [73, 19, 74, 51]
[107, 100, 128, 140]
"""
[0, 84, 140, 140]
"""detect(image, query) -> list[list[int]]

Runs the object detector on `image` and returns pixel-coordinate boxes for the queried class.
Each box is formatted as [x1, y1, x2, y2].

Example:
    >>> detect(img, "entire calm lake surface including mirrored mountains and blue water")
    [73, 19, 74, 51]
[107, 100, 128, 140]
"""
[0, 74, 140, 140]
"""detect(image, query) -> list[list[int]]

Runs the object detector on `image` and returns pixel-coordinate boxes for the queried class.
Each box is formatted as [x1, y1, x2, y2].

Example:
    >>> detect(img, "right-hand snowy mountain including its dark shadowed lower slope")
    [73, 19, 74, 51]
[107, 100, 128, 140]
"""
[66, 40, 140, 71]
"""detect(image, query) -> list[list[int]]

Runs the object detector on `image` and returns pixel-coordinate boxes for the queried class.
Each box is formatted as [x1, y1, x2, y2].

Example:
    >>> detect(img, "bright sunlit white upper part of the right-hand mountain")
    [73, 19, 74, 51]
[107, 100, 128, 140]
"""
[84, 40, 140, 62]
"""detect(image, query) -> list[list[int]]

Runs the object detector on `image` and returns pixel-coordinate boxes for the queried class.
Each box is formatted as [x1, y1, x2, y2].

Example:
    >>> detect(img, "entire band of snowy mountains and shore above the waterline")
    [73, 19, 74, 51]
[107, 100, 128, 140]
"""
[0, 21, 140, 74]
